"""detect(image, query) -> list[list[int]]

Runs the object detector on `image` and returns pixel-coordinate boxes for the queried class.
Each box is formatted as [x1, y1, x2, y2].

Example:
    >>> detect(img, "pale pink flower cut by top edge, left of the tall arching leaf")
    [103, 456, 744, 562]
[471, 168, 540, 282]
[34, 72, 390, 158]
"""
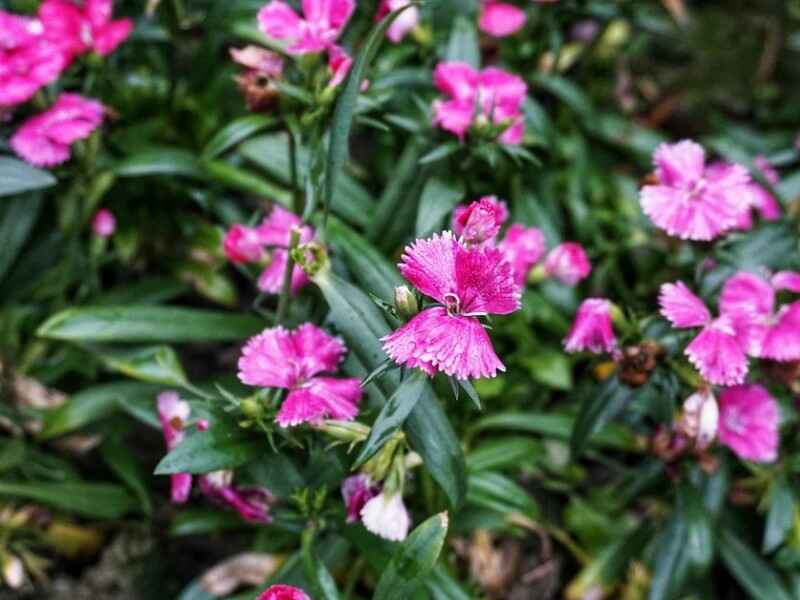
[258, 0, 356, 54]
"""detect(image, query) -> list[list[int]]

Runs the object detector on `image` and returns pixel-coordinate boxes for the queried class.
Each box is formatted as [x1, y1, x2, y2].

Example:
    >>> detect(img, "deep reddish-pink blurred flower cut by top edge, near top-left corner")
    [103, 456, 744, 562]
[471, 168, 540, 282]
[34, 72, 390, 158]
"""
[39, 0, 133, 57]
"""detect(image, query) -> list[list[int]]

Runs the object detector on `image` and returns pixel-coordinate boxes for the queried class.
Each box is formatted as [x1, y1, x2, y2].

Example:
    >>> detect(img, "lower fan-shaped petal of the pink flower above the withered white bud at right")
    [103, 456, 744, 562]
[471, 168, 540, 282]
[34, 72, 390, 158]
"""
[685, 315, 748, 385]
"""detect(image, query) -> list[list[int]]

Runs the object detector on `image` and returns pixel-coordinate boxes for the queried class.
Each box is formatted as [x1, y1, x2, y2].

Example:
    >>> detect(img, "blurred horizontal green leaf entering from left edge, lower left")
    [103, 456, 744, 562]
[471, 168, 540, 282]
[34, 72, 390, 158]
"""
[0, 481, 136, 519]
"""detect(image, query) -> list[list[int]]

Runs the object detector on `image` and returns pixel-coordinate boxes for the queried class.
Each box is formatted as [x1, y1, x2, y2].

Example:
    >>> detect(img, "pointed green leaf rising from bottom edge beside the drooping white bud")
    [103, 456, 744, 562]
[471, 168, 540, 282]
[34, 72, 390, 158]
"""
[373, 513, 448, 600]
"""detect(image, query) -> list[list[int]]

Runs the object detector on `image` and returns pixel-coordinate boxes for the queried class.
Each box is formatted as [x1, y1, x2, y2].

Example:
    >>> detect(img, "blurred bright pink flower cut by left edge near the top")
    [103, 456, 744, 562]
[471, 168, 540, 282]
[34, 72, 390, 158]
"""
[0, 10, 69, 107]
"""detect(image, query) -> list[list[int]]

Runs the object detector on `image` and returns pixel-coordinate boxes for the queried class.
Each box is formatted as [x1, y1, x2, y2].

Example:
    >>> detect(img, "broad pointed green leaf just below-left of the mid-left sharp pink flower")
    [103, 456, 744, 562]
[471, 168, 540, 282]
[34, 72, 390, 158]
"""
[155, 420, 260, 475]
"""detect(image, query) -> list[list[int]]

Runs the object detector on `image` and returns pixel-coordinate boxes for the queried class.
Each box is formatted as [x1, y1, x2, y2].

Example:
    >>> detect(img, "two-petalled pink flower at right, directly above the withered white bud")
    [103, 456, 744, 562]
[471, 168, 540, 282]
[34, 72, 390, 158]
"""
[659, 281, 748, 385]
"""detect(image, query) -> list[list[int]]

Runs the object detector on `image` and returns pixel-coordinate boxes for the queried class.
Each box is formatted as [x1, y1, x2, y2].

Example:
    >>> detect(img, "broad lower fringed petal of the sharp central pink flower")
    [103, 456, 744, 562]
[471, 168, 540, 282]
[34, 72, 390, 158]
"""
[382, 307, 505, 379]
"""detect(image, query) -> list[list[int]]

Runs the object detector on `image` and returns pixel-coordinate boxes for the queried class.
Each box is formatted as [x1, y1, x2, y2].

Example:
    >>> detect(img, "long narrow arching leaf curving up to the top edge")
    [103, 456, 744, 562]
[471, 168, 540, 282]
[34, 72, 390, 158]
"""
[323, 3, 416, 225]
